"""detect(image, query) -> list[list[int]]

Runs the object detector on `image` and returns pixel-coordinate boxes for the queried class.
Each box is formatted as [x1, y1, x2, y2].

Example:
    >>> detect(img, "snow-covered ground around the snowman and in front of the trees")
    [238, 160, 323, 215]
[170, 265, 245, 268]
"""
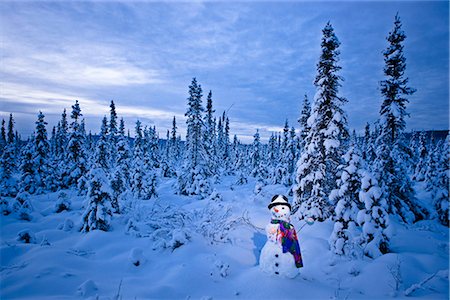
[0, 177, 449, 299]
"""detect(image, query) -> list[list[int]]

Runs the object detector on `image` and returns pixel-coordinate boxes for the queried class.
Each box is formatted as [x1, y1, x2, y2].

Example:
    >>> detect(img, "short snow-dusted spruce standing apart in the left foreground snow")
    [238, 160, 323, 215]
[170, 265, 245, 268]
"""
[81, 167, 112, 232]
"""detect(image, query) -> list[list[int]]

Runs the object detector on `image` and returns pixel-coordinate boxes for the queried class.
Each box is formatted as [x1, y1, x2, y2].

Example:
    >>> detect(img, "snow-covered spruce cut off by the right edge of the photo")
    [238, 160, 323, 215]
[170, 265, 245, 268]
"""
[431, 135, 450, 227]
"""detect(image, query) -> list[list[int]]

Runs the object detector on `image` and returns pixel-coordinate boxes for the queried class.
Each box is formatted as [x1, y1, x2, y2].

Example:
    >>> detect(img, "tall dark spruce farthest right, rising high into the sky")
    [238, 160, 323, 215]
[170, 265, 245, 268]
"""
[373, 15, 426, 223]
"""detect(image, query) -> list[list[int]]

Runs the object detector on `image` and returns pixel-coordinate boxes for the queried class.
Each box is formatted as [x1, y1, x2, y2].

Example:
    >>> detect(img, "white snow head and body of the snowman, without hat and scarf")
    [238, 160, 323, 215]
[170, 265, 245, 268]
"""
[259, 196, 299, 278]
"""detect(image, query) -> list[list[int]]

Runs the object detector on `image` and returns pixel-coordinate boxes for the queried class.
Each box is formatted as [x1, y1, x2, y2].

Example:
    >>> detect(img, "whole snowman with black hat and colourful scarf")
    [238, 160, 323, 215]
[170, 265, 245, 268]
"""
[259, 195, 303, 278]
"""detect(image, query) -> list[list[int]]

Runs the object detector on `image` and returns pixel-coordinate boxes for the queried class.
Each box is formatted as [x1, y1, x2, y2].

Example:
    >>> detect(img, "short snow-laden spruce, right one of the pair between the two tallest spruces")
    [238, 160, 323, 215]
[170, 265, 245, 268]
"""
[357, 172, 389, 258]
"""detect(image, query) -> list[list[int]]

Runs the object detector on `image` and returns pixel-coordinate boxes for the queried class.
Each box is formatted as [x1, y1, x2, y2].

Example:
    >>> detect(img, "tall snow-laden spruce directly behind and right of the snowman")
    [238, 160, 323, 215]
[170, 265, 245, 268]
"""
[293, 23, 349, 221]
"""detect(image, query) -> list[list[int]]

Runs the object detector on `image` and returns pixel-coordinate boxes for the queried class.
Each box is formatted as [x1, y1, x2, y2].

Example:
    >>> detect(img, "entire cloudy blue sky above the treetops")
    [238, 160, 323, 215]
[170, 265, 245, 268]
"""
[0, 1, 449, 141]
